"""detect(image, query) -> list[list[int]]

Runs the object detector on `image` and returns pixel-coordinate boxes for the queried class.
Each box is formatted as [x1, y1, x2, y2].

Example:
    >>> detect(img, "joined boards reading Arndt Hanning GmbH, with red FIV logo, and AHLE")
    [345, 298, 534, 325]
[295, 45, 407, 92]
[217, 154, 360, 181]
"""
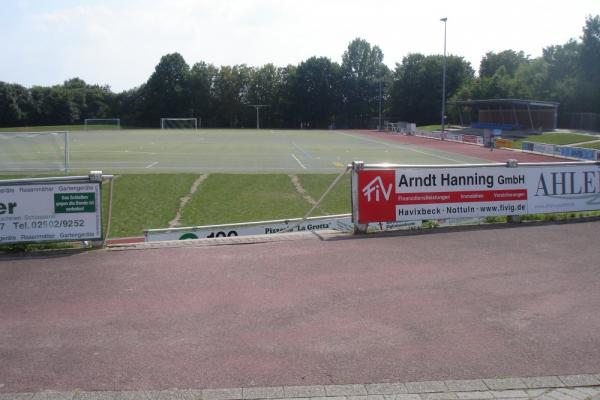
[354, 163, 600, 224]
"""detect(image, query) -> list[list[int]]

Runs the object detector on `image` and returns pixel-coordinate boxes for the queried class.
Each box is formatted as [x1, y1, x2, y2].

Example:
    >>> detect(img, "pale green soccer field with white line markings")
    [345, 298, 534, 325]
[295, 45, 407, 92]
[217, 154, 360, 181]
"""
[0, 129, 485, 173]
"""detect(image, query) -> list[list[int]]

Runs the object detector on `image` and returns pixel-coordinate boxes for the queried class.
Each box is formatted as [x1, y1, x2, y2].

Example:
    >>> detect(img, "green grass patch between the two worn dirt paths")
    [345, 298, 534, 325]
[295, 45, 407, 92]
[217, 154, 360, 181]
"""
[181, 174, 310, 226]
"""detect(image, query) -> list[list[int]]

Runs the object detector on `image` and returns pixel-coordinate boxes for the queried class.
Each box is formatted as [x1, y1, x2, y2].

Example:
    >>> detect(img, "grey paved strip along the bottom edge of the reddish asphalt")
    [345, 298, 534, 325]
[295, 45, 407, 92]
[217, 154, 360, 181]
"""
[0, 374, 600, 400]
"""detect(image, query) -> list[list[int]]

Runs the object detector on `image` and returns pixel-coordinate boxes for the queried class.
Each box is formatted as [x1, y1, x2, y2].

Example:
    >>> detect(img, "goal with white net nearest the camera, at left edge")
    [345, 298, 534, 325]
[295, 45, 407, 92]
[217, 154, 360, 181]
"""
[0, 132, 69, 173]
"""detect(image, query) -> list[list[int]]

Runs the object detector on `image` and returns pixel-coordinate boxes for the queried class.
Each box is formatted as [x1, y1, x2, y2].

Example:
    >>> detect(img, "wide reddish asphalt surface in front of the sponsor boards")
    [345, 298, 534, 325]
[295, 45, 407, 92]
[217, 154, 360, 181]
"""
[0, 222, 600, 392]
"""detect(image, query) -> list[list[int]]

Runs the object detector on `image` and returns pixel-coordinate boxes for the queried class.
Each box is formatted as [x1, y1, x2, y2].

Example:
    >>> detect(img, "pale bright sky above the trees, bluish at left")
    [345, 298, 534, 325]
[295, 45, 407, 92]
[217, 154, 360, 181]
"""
[0, 0, 600, 91]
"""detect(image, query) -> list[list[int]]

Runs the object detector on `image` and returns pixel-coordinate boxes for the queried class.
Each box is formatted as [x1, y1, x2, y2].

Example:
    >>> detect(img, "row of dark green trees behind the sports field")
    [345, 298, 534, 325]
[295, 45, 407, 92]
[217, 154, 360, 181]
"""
[0, 16, 600, 128]
